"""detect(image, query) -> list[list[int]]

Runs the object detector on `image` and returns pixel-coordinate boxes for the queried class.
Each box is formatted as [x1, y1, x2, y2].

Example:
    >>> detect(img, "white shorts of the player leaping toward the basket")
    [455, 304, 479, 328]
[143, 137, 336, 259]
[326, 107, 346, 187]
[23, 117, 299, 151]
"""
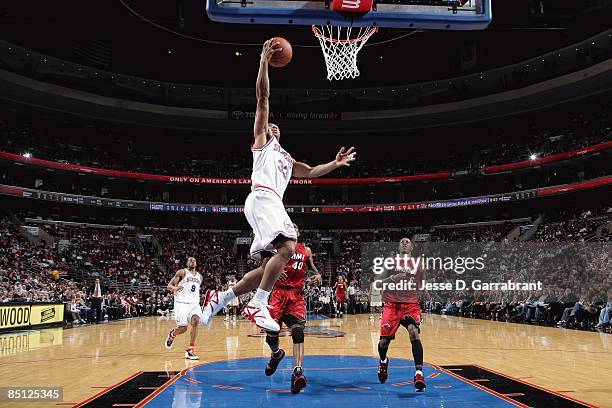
[244, 190, 297, 260]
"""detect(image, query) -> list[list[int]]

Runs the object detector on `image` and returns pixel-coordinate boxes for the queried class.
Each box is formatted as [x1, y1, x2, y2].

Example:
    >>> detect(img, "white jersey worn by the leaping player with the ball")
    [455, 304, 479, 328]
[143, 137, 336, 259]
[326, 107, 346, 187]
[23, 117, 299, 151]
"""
[251, 136, 294, 200]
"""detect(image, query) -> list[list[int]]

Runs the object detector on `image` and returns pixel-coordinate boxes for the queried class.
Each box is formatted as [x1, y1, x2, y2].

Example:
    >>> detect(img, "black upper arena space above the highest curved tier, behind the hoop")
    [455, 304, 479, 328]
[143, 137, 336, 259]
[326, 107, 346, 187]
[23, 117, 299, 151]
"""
[0, 0, 612, 89]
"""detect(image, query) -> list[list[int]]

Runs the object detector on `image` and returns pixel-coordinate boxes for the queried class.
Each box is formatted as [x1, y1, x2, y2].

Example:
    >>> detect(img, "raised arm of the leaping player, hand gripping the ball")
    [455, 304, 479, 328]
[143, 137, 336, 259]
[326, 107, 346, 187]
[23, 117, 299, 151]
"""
[253, 39, 282, 149]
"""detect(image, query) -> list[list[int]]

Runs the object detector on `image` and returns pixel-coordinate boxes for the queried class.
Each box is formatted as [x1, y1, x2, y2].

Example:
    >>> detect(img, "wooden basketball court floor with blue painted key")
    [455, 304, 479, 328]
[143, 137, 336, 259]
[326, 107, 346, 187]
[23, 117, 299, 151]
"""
[0, 314, 612, 407]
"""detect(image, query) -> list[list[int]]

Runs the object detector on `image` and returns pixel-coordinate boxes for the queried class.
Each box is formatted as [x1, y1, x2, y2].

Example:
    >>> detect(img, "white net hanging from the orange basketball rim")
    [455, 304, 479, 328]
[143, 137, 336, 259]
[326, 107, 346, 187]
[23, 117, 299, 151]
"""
[312, 25, 378, 81]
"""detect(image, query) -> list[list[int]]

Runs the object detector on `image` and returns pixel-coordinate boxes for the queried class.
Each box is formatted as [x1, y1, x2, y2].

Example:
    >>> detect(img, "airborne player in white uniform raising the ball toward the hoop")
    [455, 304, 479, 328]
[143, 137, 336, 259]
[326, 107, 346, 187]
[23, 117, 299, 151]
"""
[202, 39, 356, 331]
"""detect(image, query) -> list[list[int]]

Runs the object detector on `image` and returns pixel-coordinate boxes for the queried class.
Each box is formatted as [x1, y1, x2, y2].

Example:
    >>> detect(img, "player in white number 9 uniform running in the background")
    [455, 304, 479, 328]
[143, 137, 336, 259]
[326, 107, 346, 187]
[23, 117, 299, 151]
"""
[165, 257, 202, 360]
